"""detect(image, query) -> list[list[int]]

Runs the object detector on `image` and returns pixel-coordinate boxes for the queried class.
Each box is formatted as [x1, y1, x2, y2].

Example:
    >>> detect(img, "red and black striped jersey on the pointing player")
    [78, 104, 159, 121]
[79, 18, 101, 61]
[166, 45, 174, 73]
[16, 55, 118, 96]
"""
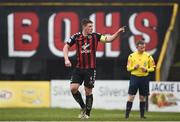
[67, 32, 102, 69]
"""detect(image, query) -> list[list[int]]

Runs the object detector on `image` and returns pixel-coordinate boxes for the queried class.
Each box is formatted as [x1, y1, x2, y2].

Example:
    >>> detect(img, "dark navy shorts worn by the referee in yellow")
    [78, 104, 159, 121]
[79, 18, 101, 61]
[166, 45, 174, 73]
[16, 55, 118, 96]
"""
[128, 75, 149, 96]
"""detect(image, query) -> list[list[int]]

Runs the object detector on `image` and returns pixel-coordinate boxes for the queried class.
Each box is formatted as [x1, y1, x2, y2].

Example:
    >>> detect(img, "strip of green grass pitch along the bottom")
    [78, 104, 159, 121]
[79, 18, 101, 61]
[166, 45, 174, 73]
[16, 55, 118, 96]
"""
[0, 108, 180, 121]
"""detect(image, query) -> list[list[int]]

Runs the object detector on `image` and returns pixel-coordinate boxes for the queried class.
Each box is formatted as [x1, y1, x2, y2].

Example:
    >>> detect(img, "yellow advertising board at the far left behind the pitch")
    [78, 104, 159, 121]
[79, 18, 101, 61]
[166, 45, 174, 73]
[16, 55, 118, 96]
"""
[0, 81, 50, 108]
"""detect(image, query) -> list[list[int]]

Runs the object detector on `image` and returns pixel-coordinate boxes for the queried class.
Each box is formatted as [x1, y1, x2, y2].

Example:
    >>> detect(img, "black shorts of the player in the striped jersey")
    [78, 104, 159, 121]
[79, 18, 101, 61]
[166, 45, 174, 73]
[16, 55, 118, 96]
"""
[71, 68, 96, 88]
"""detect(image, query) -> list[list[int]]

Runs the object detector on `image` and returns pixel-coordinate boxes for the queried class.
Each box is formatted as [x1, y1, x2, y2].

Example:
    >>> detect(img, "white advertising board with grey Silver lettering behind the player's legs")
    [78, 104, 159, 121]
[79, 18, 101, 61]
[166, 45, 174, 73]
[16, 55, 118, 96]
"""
[51, 80, 139, 110]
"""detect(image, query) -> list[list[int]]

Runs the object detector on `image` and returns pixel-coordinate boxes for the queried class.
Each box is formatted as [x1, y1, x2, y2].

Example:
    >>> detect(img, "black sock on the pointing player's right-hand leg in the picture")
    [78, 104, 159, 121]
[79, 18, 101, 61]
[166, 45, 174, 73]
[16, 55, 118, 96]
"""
[86, 94, 93, 116]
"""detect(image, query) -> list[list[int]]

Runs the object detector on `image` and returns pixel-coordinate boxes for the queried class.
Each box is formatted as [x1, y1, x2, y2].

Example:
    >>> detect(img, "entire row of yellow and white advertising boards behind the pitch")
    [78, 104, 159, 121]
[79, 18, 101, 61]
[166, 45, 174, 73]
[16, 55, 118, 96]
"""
[0, 80, 180, 112]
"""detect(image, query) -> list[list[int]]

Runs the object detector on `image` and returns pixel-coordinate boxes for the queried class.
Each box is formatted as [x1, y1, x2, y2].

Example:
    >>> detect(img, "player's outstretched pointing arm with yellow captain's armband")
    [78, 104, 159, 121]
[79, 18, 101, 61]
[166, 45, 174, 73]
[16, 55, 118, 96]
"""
[100, 26, 126, 43]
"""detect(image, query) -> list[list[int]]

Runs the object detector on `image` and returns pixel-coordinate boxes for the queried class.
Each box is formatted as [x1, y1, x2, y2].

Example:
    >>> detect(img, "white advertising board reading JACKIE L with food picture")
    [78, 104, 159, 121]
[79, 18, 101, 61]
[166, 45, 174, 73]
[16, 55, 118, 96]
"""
[149, 81, 180, 112]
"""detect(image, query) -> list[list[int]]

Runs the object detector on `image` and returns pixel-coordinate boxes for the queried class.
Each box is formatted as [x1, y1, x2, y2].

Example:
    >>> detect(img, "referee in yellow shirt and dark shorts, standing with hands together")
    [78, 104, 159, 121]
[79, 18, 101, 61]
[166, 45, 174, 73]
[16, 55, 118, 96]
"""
[125, 41, 155, 119]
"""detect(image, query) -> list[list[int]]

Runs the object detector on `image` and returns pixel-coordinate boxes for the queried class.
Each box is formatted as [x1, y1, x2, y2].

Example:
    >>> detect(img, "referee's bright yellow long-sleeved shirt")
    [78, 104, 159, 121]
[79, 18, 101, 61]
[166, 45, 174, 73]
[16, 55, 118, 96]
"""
[127, 52, 155, 76]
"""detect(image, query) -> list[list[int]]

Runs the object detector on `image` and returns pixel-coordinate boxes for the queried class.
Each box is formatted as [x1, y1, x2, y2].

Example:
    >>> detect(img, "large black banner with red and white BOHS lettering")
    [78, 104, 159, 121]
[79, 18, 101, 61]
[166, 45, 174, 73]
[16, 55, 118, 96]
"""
[0, 2, 173, 79]
